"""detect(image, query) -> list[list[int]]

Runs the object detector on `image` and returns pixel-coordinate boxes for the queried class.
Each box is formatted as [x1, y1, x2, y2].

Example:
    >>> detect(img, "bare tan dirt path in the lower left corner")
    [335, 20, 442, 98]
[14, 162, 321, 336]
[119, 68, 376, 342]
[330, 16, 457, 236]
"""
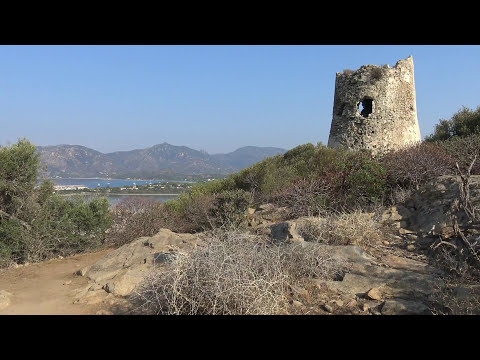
[0, 249, 112, 315]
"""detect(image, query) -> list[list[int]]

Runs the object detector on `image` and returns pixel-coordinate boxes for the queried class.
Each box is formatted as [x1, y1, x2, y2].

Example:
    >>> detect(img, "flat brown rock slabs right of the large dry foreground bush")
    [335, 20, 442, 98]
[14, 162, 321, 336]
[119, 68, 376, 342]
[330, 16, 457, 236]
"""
[310, 246, 445, 315]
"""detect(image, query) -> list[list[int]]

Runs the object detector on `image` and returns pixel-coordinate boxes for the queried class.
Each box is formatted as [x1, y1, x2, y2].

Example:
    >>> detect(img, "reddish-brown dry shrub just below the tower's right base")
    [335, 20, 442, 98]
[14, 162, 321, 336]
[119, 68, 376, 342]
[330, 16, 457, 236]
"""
[382, 142, 455, 189]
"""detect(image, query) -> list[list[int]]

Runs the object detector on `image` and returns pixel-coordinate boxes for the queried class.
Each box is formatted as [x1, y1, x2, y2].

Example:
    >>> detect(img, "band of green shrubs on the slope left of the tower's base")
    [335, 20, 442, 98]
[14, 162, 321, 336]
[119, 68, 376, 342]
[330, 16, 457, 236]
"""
[166, 144, 387, 228]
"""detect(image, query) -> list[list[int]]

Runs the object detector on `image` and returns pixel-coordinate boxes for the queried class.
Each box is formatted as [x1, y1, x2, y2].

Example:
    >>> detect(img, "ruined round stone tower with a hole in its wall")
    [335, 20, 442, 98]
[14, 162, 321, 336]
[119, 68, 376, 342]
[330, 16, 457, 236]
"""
[328, 56, 421, 153]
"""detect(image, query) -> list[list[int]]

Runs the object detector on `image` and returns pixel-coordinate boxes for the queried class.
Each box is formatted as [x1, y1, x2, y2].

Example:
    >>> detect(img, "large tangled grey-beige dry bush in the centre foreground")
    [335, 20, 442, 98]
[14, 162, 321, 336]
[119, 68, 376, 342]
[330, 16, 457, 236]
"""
[133, 231, 340, 315]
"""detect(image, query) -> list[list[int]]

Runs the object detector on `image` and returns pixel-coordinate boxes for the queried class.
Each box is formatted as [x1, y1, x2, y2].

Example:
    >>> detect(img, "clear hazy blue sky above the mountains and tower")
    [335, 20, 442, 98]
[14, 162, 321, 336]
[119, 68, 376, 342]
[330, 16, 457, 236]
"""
[0, 45, 480, 153]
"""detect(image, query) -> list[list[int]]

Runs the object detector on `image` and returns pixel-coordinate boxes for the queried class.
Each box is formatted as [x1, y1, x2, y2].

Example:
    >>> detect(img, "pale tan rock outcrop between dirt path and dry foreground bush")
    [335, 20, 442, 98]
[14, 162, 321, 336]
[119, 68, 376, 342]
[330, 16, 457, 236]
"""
[77, 229, 201, 302]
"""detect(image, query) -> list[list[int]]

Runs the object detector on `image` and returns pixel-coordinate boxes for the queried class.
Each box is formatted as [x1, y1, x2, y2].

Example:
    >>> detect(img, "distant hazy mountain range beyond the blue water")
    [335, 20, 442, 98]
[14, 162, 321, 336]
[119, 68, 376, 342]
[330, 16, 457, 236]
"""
[37, 143, 286, 179]
